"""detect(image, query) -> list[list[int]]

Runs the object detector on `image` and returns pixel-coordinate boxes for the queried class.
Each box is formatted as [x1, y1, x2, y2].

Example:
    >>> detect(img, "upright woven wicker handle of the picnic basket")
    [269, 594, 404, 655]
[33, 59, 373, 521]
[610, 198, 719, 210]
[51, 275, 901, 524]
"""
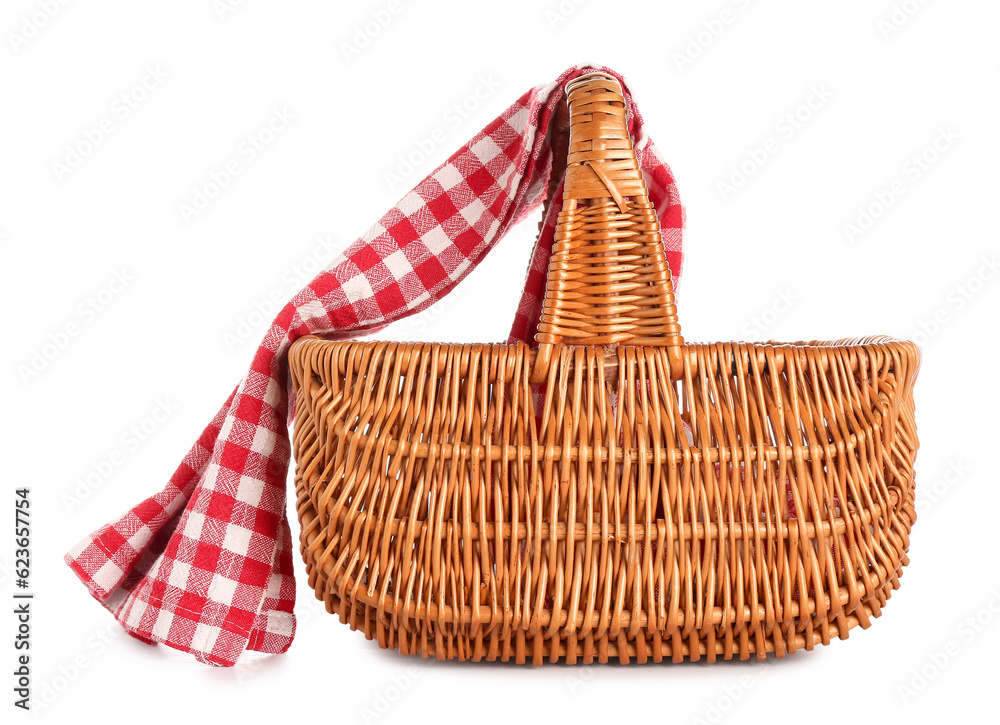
[532, 73, 684, 382]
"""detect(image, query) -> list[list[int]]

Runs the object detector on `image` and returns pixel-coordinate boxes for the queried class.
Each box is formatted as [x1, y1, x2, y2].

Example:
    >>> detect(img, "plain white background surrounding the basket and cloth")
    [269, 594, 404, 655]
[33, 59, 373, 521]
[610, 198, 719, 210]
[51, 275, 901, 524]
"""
[0, 0, 1000, 723]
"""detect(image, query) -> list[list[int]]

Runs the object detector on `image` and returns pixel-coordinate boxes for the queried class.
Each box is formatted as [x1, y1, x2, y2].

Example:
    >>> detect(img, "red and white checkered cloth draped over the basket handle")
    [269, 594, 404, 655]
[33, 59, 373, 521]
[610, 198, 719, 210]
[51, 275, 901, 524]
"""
[66, 65, 683, 665]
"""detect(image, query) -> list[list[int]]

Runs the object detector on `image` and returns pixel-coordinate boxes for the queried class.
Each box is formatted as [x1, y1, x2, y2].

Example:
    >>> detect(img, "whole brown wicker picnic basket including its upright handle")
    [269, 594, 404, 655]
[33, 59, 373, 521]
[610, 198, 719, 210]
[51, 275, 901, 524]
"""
[289, 74, 919, 664]
